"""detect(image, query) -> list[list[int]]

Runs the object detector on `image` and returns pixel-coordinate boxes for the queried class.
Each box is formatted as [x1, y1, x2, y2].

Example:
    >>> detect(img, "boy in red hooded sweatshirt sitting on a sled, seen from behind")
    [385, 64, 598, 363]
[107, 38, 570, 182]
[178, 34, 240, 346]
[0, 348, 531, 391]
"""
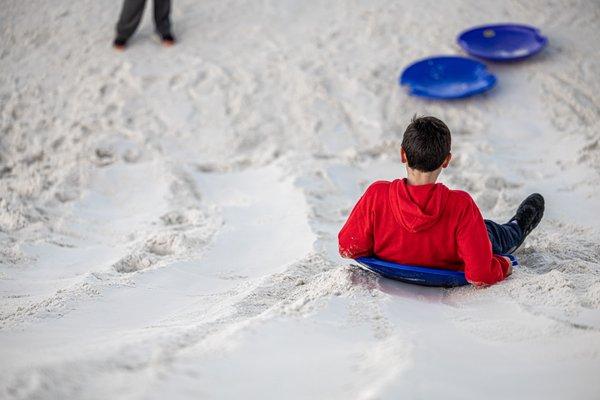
[338, 117, 544, 286]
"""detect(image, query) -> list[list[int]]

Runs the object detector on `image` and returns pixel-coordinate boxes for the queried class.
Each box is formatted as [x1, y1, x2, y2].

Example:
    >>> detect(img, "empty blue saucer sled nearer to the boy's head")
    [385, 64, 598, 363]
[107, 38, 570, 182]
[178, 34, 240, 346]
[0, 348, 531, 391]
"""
[399, 56, 496, 99]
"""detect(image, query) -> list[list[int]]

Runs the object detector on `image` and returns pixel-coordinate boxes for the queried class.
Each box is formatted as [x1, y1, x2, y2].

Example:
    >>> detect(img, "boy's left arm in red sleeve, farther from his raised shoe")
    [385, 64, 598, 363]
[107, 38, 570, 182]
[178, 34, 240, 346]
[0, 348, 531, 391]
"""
[338, 186, 373, 258]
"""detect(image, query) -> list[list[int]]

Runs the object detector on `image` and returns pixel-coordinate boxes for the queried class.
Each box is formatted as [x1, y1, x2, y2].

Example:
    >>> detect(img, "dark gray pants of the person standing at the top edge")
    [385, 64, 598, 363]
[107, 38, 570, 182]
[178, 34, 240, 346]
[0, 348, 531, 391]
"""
[117, 0, 171, 40]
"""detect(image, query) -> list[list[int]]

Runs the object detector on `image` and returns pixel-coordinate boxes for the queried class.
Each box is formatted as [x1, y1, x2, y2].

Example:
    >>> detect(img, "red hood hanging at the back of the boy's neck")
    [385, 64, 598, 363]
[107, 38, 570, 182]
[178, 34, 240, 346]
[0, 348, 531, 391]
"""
[389, 179, 450, 232]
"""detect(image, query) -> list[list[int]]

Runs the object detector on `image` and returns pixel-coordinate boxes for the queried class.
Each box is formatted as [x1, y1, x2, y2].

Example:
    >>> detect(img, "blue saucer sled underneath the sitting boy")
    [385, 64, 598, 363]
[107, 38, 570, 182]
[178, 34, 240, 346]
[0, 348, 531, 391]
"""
[356, 254, 519, 287]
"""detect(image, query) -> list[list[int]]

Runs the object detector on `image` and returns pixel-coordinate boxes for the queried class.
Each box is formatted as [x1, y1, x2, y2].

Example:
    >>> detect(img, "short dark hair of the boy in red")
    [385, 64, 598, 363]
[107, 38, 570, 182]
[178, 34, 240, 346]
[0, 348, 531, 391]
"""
[402, 115, 450, 172]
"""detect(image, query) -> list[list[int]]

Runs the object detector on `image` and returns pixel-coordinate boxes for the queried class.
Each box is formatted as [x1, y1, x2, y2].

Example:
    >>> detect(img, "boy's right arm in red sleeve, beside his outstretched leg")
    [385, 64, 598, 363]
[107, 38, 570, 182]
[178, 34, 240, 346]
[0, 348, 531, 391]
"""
[457, 199, 511, 286]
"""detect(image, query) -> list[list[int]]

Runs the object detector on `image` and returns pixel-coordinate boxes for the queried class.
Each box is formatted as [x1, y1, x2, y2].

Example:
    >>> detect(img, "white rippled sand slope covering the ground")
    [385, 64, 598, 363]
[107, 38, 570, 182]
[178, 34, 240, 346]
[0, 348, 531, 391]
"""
[0, 0, 600, 399]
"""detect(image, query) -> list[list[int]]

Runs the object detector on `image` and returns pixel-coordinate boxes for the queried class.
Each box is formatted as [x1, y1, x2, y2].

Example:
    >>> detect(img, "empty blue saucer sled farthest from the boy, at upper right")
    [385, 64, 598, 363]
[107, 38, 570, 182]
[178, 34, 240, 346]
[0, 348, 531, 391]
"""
[456, 24, 548, 61]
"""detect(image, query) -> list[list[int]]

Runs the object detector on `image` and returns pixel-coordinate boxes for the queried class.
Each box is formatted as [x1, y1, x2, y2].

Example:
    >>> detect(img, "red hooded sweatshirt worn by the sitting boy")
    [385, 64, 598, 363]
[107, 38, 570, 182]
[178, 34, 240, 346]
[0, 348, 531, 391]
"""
[338, 179, 509, 285]
